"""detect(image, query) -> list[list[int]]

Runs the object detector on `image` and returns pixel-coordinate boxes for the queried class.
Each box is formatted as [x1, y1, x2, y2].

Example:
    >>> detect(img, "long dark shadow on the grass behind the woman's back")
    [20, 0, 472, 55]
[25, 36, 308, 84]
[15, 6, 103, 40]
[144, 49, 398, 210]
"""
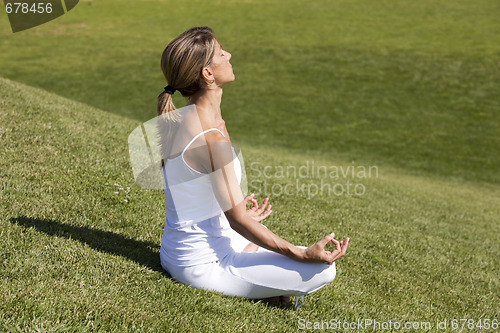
[10, 216, 170, 277]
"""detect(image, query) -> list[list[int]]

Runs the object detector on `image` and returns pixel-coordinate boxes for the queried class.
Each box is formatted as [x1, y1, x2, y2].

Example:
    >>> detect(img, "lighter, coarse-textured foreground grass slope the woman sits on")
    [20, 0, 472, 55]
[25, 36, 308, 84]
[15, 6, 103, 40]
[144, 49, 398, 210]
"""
[0, 79, 500, 331]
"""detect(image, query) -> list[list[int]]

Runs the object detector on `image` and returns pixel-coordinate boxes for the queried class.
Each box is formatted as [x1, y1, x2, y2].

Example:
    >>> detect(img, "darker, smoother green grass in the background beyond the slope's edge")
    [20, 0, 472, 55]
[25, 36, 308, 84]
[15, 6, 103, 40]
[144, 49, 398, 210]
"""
[0, 0, 500, 183]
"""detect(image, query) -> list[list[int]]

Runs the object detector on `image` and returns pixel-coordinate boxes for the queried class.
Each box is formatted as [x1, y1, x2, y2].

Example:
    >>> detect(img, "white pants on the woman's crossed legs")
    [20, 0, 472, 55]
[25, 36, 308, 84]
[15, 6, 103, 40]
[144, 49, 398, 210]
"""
[162, 248, 336, 299]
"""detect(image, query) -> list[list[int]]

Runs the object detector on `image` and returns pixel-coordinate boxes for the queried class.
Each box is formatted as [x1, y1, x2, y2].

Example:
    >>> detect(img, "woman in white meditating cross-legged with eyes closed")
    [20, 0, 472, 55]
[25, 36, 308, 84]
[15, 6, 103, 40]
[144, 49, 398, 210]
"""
[158, 27, 349, 303]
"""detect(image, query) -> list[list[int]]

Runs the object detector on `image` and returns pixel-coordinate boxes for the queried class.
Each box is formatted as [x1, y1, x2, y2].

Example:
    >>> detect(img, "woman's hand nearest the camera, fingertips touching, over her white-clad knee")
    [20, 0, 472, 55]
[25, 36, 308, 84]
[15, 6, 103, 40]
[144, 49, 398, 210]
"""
[302, 233, 349, 265]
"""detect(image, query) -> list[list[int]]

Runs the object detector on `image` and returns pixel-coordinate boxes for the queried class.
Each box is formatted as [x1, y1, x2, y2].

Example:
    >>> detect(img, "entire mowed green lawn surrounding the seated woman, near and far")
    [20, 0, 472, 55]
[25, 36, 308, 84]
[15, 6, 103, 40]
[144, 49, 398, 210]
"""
[0, 0, 500, 332]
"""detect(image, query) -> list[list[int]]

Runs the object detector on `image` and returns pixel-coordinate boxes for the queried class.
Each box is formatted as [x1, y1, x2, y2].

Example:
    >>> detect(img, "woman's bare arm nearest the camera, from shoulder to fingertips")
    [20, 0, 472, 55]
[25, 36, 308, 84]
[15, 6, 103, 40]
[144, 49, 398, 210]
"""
[202, 132, 349, 264]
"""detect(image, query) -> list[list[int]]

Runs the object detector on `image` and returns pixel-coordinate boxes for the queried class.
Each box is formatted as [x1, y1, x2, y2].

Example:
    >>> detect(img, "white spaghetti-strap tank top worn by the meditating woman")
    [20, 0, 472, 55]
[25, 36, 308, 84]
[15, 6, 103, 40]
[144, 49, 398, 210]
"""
[160, 128, 242, 266]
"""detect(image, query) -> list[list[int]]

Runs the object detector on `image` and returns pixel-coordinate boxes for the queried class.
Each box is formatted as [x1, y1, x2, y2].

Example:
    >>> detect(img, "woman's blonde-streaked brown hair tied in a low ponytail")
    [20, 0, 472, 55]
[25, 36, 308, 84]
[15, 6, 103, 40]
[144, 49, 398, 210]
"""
[158, 27, 215, 115]
